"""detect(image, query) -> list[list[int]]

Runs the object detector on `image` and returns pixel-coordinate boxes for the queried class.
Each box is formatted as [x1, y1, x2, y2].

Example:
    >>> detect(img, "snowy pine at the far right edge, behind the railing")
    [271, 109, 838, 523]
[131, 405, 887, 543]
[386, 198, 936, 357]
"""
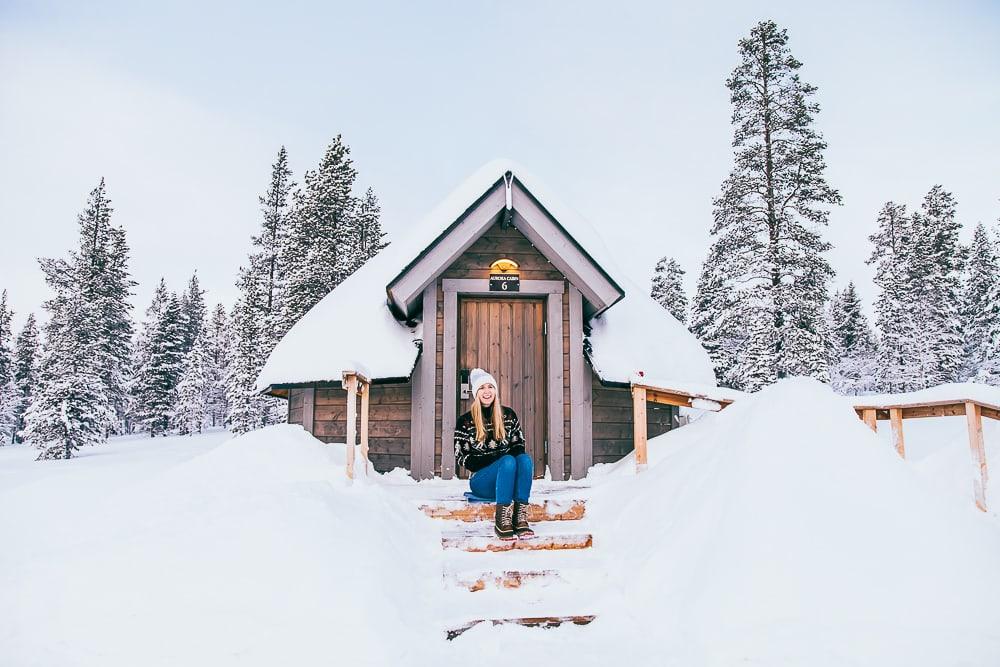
[961, 223, 1000, 384]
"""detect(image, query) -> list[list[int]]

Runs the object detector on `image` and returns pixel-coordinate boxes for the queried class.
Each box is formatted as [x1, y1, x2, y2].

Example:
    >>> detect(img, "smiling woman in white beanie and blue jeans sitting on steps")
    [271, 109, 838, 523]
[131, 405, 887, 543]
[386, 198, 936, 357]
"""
[455, 368, 535, 540]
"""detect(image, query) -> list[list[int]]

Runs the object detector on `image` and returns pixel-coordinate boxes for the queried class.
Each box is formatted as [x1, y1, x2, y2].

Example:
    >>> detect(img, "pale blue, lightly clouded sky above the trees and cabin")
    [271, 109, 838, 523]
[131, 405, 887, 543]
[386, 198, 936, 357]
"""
[0, 0, 1000, 326]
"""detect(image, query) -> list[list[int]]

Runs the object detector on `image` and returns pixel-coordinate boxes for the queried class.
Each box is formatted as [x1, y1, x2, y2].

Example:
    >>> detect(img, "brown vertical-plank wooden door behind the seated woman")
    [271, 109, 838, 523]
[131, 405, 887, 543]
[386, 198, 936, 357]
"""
[456, 297, 547, 477]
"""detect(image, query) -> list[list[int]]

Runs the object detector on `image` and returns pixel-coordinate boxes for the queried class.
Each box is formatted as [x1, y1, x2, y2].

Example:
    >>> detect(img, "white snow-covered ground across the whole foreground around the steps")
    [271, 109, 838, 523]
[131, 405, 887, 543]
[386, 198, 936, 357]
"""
[0, 379, 1000, 667]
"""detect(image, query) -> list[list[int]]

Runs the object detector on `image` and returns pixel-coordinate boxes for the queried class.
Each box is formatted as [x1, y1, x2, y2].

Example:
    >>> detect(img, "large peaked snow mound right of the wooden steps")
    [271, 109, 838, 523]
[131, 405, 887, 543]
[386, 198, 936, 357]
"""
[589, 378, 1000, 667]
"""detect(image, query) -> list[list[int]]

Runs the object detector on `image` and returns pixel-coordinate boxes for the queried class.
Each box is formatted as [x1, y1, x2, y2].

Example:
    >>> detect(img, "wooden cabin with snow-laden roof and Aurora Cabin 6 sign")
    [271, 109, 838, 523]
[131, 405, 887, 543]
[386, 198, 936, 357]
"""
[257, 160, 715, 480]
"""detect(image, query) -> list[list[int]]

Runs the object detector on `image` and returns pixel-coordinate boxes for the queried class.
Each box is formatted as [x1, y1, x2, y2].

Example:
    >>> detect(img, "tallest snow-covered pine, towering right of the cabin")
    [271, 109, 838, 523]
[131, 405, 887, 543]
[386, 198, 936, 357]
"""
[711, 21, 841, 391]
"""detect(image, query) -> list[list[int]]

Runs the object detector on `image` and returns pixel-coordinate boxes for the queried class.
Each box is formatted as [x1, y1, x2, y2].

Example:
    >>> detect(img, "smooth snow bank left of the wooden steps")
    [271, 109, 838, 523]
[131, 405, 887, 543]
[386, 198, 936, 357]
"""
[0, 425, 441, 666]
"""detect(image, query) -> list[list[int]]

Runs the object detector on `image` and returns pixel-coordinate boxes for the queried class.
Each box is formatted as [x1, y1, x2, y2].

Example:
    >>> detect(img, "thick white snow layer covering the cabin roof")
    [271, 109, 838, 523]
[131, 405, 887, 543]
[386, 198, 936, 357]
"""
[257, 160, 715, 391]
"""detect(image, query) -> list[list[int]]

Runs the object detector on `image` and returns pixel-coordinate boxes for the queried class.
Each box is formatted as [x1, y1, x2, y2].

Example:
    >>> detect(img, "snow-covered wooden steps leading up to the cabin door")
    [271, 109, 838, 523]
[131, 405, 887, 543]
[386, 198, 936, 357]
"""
[420, 494, 596, 640]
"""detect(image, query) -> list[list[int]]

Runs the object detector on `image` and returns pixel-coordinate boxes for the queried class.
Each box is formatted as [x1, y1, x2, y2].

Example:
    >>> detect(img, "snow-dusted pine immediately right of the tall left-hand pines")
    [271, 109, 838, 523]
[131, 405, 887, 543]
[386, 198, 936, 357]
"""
[135, 293, 184, 437]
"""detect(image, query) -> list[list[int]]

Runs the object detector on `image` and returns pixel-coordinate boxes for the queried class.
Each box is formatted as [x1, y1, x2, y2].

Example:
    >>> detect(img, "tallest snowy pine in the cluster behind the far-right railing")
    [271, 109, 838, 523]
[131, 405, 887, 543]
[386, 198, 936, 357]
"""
[908, 185, 967, 386]
